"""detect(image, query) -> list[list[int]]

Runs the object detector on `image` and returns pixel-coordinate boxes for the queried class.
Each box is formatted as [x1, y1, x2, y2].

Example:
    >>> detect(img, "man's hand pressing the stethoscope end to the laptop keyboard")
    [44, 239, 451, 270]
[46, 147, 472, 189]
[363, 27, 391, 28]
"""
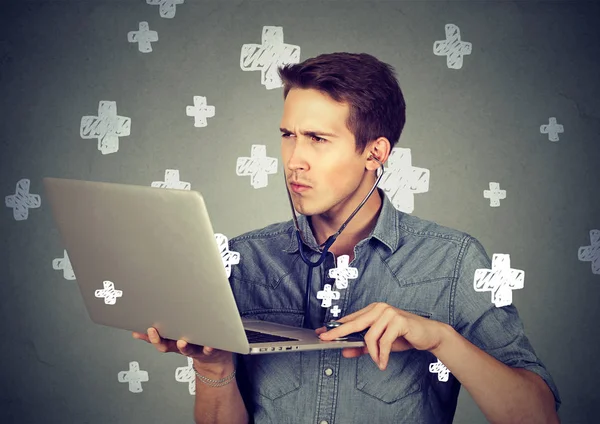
[315, 302, 443, 370]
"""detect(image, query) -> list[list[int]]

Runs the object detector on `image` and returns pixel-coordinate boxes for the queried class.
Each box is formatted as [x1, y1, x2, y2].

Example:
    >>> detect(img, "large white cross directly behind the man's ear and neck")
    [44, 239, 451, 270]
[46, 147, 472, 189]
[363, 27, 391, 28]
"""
[378, 147, 429, 213]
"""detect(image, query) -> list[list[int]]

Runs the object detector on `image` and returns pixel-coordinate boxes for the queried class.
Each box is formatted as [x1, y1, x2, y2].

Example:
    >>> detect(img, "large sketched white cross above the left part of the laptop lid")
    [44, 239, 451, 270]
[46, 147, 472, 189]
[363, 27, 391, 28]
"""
[79, 100, 131, 155]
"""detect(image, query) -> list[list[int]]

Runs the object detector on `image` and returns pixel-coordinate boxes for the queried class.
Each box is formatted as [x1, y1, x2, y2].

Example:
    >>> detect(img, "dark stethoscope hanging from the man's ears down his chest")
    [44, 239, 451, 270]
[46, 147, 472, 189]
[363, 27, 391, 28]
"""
[283, 155, 385, 328]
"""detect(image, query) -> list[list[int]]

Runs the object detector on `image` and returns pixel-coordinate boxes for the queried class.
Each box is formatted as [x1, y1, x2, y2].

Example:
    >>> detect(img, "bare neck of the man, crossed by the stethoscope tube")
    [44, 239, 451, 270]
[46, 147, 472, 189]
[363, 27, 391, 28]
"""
[309, 188, 383, 252]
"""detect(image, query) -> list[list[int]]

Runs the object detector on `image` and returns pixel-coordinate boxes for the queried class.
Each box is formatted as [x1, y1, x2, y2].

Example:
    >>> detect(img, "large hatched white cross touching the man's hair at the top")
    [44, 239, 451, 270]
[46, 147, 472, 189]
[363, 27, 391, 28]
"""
[240, 26, 300, 90]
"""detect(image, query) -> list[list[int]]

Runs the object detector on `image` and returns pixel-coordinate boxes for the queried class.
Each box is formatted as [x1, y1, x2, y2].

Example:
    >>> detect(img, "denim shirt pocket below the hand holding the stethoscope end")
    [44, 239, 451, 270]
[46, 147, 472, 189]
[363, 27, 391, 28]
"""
[356, 311, 431, 403]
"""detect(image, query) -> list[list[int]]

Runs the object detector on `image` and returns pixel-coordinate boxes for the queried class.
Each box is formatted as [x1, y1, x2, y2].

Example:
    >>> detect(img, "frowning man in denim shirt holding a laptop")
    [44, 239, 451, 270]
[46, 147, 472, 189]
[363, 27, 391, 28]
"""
[134, 53, 560, 424]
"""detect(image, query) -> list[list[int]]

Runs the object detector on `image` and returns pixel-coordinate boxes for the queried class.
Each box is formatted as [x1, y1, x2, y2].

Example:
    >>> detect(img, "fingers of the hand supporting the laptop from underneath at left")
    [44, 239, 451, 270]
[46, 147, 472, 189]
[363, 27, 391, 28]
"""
[132, 327, 233, 364]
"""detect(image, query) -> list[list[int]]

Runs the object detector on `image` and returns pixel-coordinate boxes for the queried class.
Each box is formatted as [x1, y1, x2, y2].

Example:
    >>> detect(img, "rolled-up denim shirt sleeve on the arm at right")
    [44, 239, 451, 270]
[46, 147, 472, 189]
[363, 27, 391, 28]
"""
[450, 236, 561, 411]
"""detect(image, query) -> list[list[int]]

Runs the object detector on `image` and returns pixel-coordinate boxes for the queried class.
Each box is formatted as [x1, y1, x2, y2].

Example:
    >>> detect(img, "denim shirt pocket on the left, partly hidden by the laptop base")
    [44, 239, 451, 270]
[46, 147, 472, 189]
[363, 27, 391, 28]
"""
[244, 312, 303, 401]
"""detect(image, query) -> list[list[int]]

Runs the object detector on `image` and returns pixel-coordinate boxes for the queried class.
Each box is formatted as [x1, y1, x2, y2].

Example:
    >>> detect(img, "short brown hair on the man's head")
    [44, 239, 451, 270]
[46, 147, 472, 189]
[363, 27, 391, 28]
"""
[278, 53, 406, 154]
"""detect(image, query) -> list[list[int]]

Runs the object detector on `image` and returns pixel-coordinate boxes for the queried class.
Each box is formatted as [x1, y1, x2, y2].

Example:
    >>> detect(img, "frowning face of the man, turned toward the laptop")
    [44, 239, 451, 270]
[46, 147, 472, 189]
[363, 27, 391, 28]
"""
[280, 89, 369, 215]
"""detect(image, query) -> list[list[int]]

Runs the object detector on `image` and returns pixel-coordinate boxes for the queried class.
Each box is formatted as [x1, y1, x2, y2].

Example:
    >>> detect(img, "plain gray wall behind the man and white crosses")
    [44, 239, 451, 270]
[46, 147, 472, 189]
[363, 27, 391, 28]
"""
[0, 0, 600, 423]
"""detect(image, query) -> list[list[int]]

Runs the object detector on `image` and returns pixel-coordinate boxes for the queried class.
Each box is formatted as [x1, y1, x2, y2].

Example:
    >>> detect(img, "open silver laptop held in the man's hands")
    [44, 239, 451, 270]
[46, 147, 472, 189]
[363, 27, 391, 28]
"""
[43, 177, 365, 354]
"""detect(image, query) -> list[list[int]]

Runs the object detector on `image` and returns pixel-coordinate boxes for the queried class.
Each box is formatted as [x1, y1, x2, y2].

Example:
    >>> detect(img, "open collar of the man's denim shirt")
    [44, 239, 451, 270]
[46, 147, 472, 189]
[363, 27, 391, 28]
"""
[283, 188, 404, 253]
